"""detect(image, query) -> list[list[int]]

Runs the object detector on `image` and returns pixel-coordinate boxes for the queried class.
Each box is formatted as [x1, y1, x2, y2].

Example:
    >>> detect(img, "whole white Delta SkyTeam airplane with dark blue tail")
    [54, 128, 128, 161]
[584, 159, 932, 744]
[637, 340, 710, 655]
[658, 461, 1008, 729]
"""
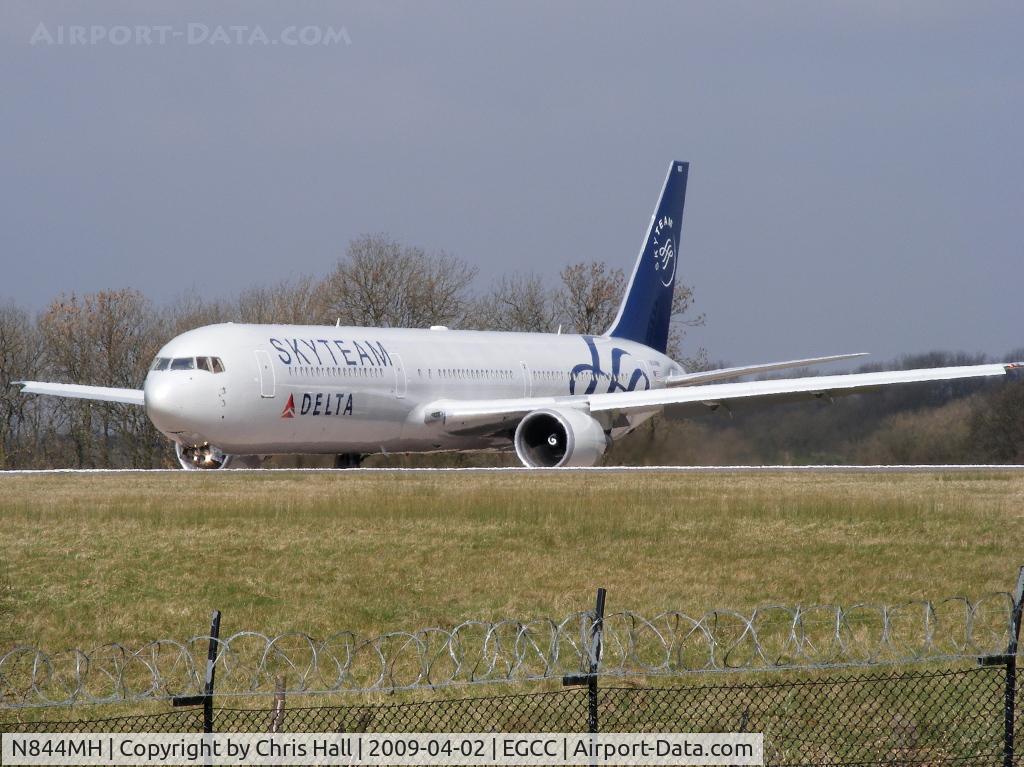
[12, 161, 1021, 469]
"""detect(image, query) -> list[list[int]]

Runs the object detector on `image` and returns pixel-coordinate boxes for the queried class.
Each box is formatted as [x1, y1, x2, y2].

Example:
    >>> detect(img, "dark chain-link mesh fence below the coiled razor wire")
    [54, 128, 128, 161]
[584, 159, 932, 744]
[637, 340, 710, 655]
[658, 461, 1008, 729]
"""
[0, 666, 1024, 765]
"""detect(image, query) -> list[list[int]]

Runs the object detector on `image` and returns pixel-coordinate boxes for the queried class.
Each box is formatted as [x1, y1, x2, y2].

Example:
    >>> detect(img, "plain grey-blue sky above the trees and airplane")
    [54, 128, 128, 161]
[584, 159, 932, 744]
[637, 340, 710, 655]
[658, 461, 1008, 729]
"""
[0, 0, 1024, 364]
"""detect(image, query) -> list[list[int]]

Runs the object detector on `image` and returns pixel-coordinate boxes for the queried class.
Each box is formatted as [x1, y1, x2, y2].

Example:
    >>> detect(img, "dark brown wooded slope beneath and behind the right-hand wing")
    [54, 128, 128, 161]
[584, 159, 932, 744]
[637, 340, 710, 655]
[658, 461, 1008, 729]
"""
[608, 349, 1024, 465]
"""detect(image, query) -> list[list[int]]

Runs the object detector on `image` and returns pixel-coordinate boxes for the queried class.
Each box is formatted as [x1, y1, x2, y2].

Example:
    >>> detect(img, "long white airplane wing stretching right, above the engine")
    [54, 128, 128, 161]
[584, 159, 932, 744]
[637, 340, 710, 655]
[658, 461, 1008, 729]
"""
[425, 363, 1024, 433]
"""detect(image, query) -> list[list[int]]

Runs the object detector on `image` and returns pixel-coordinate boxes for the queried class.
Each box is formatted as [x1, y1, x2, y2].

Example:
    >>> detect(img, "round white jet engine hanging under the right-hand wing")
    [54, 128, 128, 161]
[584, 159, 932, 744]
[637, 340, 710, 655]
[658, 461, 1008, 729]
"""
[515, 408, 608, 469]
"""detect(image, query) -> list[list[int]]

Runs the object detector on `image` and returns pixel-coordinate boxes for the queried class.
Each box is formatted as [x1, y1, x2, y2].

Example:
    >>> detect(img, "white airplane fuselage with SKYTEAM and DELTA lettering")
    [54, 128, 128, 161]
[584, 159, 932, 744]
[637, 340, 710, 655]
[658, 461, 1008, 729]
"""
[144, 324, 682, 455]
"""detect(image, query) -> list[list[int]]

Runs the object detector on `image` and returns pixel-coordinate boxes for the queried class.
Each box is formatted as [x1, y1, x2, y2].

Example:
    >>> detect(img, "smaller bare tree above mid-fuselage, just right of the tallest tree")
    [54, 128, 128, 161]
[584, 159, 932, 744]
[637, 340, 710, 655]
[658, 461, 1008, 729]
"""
[469, 274, 558, 333]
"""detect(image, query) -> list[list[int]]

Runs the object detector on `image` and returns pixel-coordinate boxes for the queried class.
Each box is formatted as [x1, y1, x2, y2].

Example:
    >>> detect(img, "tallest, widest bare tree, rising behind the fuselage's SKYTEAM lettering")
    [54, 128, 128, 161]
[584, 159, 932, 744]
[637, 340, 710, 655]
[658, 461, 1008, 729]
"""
[319, 235, 476, 328]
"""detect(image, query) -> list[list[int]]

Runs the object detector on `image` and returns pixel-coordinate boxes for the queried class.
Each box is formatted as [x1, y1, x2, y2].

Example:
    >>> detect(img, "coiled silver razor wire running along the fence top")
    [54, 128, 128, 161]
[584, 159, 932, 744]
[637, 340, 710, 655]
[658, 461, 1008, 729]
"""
[0, 593, 1013, 709]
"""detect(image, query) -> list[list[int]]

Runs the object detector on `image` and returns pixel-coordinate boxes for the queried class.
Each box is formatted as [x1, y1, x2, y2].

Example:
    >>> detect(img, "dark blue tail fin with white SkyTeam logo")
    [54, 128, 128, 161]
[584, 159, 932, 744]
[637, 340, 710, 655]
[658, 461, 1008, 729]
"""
[605, 161, 690, 352]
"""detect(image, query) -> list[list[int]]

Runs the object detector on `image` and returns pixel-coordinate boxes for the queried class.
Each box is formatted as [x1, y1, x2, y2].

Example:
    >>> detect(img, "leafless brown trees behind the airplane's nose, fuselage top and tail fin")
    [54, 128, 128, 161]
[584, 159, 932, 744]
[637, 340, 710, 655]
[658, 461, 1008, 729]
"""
[0, 235, 703, 469]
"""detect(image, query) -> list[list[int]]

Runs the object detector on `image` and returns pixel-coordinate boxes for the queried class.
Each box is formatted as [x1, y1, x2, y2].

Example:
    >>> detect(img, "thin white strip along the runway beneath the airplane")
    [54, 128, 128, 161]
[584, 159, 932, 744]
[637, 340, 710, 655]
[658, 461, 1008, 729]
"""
[0, 464, 1024, 476]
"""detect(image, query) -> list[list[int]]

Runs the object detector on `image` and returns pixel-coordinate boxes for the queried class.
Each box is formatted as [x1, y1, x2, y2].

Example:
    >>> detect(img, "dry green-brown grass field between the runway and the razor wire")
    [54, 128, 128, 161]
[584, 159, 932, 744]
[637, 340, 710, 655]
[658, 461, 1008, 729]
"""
[0, 472, 1024, 649]
